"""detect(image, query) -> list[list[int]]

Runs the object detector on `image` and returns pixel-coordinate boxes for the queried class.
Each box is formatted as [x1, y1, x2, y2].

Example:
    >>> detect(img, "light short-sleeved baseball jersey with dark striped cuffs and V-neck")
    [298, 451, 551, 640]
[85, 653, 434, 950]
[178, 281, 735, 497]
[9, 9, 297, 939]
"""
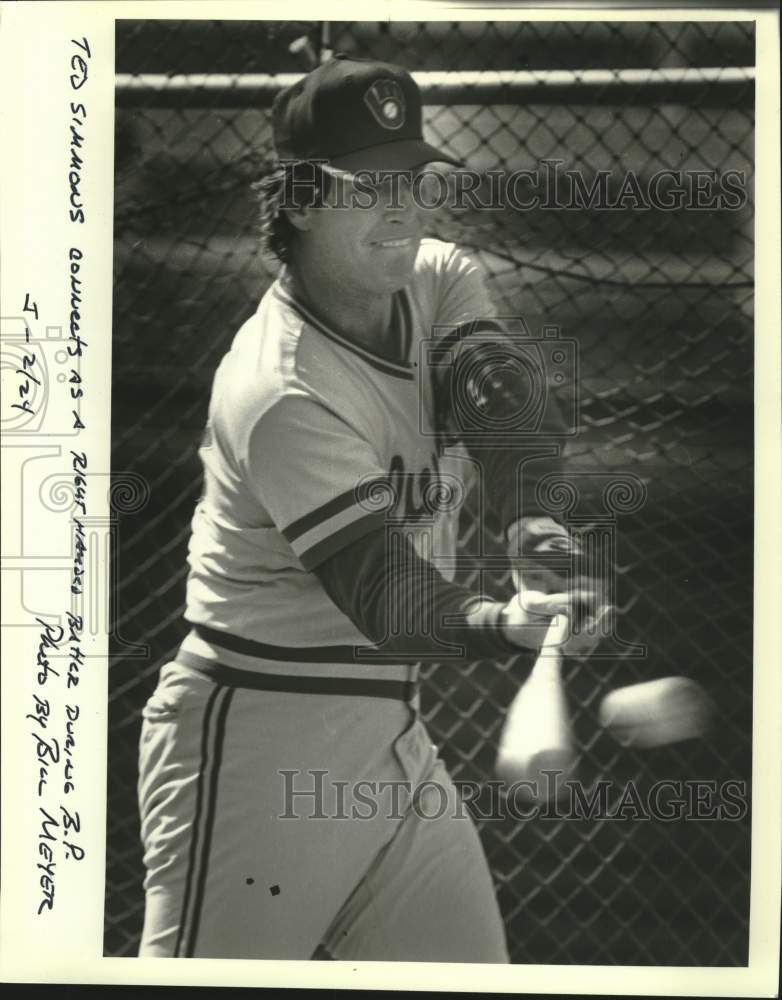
[183, 239, 492, 670]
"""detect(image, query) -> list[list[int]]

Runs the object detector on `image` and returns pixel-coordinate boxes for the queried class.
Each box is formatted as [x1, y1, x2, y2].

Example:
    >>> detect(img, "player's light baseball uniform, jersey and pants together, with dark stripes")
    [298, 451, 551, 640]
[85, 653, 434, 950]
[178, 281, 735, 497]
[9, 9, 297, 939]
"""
[139, 240, 508, 963]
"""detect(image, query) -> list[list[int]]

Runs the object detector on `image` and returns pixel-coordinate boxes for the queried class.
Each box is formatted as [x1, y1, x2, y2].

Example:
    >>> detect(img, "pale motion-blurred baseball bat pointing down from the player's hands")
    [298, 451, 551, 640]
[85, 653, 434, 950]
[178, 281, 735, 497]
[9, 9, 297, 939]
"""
[495, 614, 576, 799]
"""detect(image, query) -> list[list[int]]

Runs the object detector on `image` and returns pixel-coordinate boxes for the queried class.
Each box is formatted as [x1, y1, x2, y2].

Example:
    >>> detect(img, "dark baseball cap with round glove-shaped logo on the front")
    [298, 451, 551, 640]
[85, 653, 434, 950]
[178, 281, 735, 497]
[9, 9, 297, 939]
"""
[272, 54, 462, 174]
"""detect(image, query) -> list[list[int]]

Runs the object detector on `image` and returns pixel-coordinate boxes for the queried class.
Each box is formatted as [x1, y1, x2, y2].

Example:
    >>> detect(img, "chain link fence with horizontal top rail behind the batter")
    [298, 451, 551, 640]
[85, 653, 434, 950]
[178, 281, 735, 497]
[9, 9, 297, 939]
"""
[105, 21, 754, 965]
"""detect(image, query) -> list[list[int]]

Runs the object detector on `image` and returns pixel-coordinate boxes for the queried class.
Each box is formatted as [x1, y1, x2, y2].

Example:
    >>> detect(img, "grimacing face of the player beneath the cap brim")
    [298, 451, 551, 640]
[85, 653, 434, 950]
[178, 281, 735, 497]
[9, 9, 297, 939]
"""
[310, 174, 422, 295]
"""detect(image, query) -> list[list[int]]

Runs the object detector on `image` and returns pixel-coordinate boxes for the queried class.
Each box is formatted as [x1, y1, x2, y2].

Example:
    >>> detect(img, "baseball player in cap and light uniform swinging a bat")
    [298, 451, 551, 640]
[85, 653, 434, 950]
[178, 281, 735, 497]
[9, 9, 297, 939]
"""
[139, 57, 600, 962]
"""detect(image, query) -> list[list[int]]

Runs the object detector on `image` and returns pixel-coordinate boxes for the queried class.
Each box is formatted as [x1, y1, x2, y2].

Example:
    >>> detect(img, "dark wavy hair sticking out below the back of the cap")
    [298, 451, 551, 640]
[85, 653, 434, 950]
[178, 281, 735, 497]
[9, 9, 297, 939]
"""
[252, 161, 331, 264]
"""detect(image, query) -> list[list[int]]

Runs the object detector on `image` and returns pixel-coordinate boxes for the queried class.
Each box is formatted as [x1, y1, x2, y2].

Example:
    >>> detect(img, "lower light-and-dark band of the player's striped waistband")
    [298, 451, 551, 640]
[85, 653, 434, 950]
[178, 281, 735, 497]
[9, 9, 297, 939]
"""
[176, 649, 418, 702]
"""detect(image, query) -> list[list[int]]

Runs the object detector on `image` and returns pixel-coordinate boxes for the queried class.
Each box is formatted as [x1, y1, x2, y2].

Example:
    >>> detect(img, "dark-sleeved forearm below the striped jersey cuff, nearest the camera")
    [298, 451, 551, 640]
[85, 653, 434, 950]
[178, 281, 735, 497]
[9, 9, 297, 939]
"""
[314, 531, 519, 660]
